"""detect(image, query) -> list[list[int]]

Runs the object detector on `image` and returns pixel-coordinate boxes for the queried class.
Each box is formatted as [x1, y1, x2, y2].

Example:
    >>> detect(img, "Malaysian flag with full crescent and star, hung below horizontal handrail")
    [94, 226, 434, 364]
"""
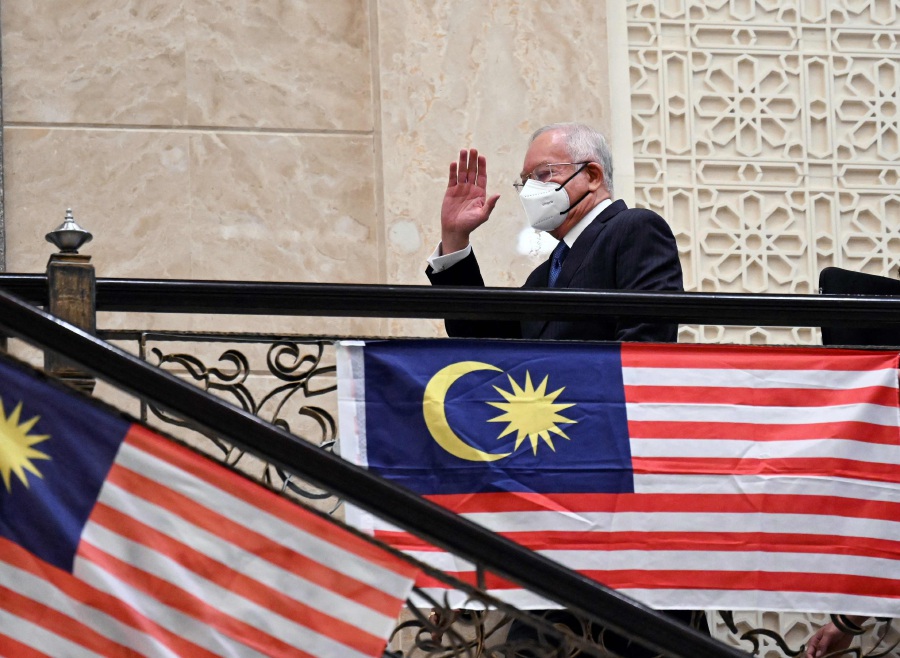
[338, 341, 900, 616]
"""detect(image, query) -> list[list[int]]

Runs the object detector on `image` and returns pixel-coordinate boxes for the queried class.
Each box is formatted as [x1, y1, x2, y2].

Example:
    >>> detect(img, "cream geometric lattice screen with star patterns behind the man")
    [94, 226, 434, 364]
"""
[626, 0, 900, 343]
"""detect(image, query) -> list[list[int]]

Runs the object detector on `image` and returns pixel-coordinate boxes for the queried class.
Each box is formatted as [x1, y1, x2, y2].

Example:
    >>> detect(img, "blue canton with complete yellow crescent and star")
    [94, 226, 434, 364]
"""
[356, 341, 634, 494]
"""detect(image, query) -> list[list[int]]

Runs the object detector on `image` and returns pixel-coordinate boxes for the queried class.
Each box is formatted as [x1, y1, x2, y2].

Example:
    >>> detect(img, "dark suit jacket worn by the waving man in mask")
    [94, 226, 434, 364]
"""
[426, 201, 684, 342]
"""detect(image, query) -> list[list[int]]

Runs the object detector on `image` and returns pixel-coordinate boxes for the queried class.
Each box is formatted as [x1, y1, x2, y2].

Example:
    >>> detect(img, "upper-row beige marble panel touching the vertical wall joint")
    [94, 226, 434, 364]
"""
[185, 0, 372, 131]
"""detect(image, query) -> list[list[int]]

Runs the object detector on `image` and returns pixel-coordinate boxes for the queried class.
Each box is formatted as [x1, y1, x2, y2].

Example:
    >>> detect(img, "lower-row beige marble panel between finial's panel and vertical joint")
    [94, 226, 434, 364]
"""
[189, 133, 383, 333]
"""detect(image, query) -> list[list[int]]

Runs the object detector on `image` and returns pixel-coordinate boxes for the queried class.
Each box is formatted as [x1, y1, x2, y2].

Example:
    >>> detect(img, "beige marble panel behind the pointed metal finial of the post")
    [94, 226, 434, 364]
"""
[4, 127, 191, 278]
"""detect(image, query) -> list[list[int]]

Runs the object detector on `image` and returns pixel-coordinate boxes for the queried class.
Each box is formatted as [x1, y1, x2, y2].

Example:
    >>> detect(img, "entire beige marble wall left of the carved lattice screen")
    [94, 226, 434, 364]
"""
[0, 0, 611, 335]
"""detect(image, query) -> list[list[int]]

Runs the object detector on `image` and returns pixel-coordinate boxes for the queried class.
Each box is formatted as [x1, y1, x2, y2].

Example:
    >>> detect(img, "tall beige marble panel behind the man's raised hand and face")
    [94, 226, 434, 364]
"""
[377, 0, 610, 296]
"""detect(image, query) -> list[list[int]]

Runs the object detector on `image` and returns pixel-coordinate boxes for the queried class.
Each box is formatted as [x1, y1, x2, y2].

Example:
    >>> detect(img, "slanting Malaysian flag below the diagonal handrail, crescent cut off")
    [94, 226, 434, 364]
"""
[0, 362, 418, 658]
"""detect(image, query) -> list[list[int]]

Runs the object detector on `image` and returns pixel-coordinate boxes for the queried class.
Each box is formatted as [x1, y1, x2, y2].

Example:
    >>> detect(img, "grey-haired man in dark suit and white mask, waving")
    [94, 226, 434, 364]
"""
[426, 124, 683, 342]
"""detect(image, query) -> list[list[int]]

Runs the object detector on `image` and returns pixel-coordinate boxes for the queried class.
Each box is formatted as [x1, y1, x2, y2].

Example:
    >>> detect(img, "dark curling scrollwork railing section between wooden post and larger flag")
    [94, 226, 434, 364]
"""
[107, 332, 341, 512]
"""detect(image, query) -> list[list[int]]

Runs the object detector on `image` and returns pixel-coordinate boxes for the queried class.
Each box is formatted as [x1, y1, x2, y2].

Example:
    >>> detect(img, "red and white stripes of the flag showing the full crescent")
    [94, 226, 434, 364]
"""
[344, 345, 900, 616]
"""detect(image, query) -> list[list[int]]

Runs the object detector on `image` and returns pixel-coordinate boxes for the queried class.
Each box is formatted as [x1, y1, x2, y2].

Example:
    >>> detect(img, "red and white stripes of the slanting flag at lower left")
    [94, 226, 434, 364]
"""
[0, 426, 418, 658]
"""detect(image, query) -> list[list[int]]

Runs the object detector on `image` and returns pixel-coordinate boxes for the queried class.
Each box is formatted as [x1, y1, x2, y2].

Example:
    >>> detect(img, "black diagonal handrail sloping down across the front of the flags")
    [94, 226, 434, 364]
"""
[0, 292, 747, 658]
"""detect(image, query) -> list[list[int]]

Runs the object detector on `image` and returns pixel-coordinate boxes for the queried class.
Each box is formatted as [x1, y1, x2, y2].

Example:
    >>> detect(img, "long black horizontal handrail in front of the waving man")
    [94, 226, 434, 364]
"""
[0, 274, 900, 327]
